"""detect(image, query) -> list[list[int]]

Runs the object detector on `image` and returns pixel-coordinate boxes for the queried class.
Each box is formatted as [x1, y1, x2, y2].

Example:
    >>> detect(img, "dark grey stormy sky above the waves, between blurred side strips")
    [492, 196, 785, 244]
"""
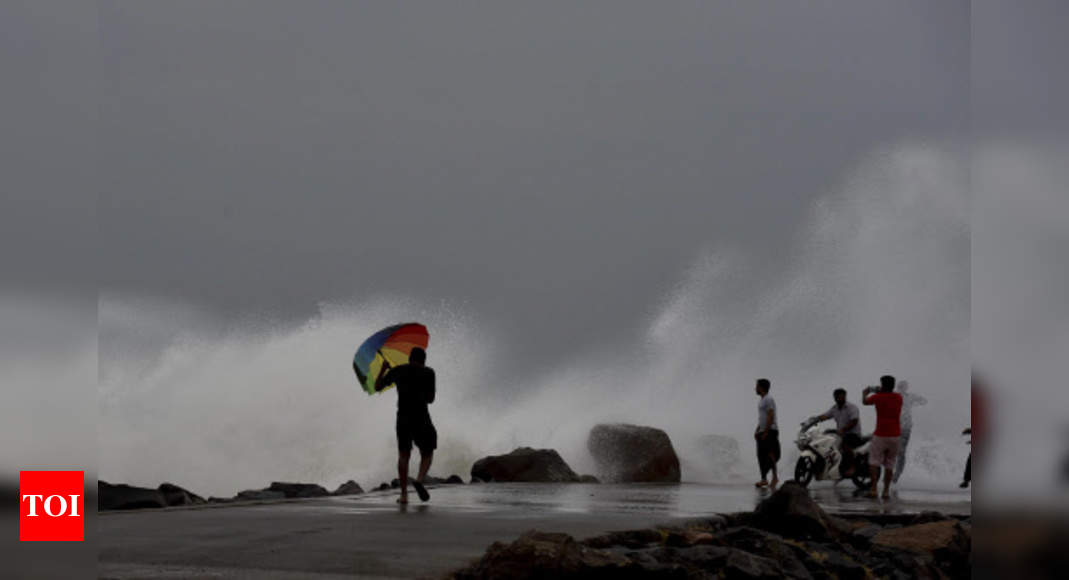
[99, 2, 970, 371]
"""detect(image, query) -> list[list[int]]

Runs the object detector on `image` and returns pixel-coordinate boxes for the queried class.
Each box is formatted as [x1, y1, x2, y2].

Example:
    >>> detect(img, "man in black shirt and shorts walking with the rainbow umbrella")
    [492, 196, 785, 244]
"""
[375, 346, 438, 504]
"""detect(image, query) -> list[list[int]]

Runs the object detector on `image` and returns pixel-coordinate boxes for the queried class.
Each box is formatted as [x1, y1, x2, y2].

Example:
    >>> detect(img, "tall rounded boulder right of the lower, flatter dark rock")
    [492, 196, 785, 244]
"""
[587, 423, 680, 483]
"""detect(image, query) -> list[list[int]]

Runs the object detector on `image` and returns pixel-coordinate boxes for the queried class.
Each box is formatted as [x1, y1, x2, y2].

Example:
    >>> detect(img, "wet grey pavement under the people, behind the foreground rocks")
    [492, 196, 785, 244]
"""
[96, 482, 971, 578]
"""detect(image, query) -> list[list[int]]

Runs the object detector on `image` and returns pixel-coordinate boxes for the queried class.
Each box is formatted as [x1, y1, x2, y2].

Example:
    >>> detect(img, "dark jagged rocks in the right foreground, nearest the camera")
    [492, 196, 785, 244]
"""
[448, 486, 972, 580]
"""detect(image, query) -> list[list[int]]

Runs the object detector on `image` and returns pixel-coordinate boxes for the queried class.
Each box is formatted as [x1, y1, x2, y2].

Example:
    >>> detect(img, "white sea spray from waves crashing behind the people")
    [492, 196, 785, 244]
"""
[98, 145, 970, 496]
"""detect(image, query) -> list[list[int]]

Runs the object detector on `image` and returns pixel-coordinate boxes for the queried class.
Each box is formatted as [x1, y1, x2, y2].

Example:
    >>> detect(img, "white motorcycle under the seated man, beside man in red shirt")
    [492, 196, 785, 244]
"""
[794, 421, 872, 489]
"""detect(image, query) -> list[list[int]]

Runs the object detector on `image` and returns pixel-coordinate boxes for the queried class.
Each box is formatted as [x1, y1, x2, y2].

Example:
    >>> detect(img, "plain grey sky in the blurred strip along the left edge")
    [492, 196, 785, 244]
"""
[0, 1, 99, 294]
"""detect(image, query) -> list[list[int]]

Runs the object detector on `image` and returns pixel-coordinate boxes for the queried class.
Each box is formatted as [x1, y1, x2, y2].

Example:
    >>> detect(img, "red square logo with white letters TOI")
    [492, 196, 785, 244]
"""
[18, 471, 86, 542]
